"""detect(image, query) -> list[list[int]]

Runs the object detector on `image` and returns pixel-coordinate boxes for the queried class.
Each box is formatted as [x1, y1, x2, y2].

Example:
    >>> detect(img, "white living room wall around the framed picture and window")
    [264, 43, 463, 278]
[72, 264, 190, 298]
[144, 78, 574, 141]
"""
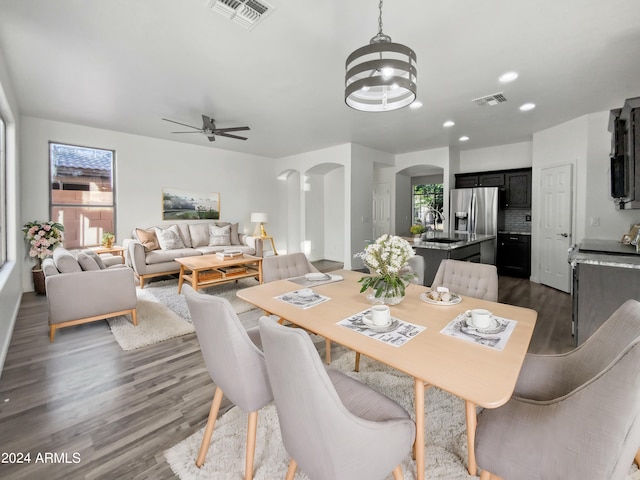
[20, 116, 278, 291]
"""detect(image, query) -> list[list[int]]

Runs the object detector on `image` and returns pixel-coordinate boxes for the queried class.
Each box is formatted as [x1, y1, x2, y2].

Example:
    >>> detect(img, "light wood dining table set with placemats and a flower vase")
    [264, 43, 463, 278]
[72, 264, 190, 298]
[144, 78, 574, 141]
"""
[237, 270, 537, 480]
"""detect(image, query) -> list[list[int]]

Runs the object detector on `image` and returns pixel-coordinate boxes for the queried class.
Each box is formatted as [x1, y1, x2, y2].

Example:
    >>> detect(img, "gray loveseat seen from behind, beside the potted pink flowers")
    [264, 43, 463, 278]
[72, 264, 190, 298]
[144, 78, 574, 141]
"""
[42, 247, 138, 342]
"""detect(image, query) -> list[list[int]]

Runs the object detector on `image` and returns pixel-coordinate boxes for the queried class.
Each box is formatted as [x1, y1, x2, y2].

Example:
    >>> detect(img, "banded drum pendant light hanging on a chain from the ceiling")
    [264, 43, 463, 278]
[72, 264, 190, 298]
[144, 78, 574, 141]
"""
[344, 0, 418, 112]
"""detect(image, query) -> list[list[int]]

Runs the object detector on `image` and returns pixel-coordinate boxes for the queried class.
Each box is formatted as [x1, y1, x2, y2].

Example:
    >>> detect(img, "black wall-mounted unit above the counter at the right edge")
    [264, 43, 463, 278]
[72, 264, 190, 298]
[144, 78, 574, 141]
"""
[609, 97, 640, 210]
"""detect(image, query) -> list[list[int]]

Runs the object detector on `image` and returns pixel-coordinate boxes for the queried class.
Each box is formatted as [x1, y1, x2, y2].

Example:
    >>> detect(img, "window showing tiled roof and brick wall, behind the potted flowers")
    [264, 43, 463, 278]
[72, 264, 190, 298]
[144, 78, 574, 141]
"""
[49, 142, 116, 248]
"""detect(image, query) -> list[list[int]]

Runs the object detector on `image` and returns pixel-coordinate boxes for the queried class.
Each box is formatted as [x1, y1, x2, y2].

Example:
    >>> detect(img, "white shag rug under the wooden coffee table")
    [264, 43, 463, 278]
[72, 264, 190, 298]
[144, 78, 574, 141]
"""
[142, 278, 258, 321]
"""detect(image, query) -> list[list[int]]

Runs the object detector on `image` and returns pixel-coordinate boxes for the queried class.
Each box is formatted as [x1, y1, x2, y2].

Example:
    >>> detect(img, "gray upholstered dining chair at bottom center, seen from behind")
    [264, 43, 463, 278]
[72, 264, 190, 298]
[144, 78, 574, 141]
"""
[259, 317, 416, 480]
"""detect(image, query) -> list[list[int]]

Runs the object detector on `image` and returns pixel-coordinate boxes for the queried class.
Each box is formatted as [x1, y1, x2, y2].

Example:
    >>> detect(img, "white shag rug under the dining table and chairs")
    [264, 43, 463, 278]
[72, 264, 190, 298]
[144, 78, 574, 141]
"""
[165, 352, 477, 480]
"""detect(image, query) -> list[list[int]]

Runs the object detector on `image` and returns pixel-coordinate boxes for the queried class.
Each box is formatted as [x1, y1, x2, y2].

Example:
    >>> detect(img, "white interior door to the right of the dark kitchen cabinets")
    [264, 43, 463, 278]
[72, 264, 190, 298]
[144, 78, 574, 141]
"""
[540, 165, 573, 293]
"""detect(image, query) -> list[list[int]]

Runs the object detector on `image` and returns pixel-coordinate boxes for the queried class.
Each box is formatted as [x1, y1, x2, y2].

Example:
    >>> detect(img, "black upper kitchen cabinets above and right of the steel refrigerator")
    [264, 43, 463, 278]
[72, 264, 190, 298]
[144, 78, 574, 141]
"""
[455, 168, 531, 208]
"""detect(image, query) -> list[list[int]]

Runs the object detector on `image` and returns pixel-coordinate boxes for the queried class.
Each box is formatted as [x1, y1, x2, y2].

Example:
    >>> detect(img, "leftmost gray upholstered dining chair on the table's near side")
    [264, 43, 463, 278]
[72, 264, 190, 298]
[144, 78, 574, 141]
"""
[182, 285, 273, 480]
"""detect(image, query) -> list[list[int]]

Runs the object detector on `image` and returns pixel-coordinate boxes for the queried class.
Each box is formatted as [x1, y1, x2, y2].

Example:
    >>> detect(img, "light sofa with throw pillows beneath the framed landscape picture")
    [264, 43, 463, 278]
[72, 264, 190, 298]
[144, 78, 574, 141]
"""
[123, 220, 262, 288]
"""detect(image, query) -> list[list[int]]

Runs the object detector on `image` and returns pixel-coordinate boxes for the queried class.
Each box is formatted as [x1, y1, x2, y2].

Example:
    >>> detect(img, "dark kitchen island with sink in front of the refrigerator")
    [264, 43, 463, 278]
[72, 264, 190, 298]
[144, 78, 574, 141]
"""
[407, 234, 496, 286]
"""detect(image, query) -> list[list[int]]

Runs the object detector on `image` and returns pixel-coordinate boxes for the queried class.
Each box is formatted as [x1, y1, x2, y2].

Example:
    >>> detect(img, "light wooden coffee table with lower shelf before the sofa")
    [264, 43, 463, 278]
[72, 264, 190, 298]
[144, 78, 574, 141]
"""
[176, 254, 262, 293]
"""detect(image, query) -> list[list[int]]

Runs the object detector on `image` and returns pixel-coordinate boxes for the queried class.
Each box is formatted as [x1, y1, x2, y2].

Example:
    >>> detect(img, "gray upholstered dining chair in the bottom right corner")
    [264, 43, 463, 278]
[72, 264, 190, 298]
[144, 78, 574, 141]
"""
[476, 300, 640, 480]
